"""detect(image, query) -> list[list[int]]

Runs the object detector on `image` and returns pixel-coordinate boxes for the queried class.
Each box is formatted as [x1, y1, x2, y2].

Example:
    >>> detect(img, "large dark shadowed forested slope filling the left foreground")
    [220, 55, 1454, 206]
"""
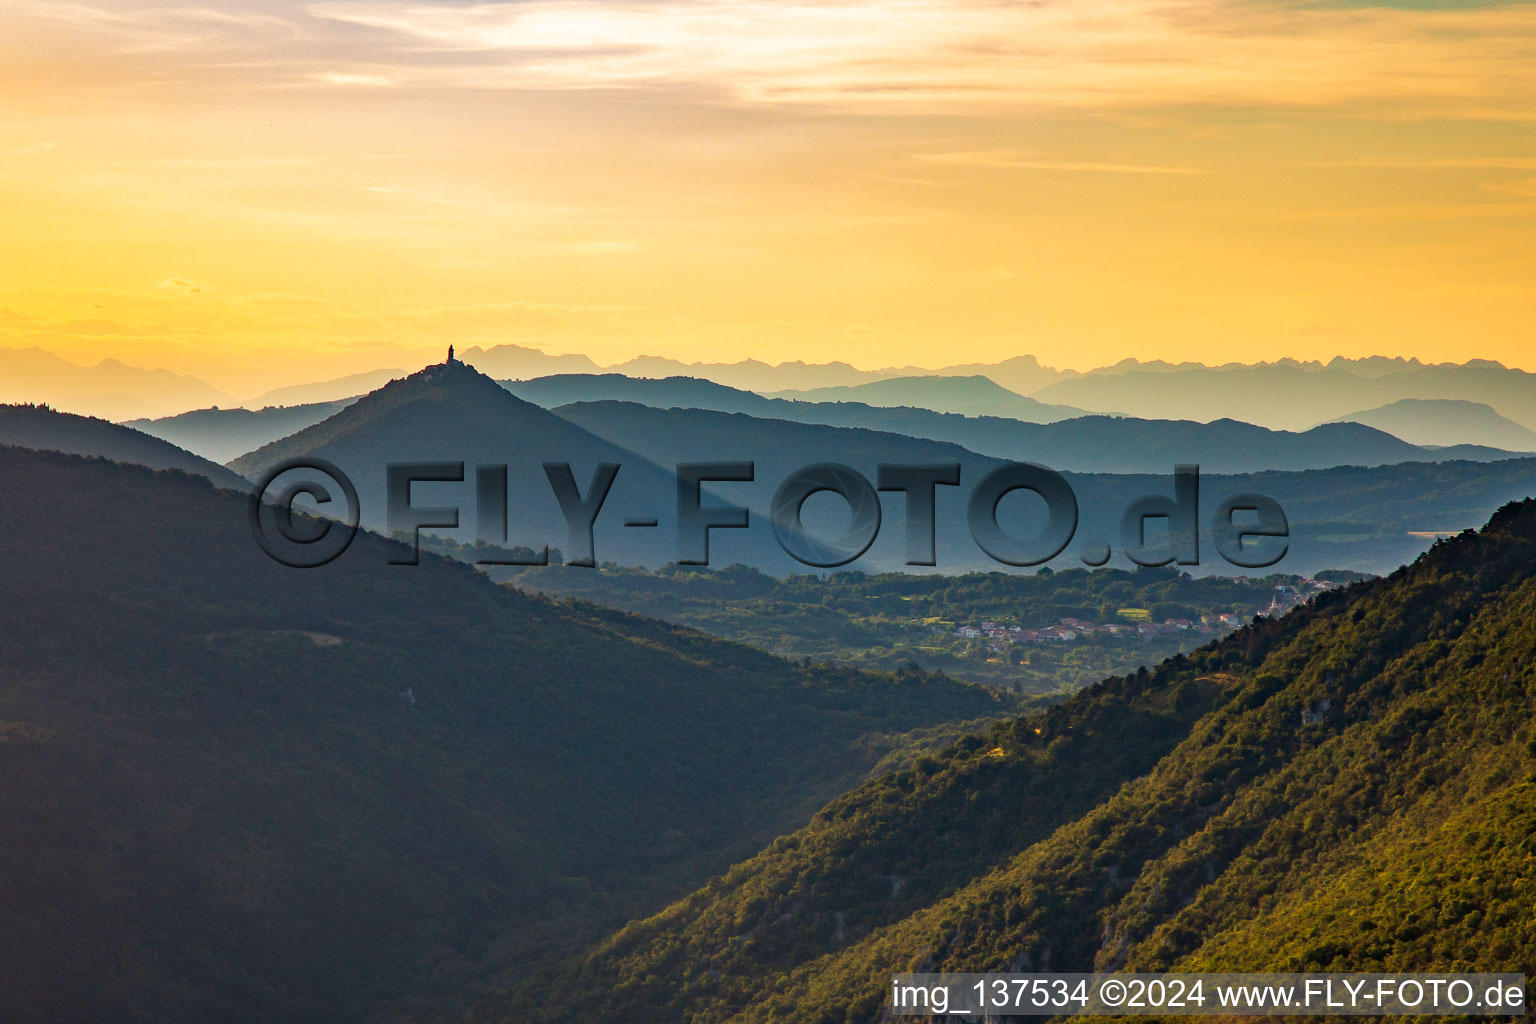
[0, 448, 1000, 1024]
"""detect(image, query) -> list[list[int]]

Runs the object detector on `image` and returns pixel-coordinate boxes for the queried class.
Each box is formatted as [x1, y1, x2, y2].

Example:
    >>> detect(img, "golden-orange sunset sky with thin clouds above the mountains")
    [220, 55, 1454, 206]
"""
[0, 0, 1536, 395]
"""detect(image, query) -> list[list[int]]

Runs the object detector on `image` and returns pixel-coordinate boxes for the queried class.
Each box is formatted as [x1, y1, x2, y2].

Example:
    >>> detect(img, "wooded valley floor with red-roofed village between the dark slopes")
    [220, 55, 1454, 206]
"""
[494, 565, 1364, 694]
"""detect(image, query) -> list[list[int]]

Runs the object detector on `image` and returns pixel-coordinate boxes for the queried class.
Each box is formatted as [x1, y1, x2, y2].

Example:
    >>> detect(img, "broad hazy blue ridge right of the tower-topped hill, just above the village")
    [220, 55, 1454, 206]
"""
[556, 402, 1536, 573]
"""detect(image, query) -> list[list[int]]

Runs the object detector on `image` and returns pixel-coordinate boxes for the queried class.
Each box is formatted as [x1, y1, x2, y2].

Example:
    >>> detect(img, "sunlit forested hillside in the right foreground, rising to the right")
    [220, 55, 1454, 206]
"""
[537, 500, 1536, 1024]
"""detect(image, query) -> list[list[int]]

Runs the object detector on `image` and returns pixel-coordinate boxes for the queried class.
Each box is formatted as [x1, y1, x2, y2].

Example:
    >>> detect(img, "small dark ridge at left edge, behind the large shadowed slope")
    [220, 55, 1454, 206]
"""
[0, 405, 249, 490]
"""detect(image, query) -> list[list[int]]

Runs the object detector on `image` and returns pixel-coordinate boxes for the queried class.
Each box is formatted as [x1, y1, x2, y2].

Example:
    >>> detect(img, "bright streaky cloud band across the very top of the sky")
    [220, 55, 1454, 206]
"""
[0, 0, 1536, 118]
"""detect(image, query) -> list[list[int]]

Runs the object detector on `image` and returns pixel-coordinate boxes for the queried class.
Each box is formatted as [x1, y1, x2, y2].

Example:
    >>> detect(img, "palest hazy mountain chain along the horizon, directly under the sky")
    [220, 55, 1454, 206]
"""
[12, 344, 1536, 447]
